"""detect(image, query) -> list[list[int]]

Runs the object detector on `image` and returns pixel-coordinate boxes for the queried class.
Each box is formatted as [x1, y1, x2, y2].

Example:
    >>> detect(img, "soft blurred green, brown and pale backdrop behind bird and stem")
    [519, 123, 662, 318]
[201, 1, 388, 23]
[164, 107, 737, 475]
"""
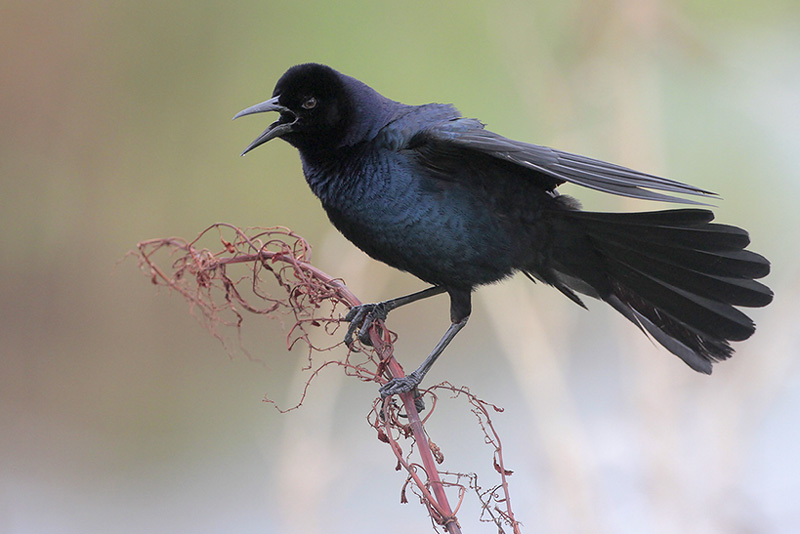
[0, 0, 800, 533]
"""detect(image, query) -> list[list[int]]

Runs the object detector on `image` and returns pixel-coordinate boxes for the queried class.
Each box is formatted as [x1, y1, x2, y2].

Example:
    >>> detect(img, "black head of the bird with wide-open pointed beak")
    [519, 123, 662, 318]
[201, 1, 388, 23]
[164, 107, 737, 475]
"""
[233, 63, 352, 155]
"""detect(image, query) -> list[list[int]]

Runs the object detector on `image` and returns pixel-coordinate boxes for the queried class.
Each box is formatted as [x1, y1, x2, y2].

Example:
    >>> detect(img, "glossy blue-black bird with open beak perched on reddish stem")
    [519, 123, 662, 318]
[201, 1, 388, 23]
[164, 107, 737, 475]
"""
[234, 63, 772, 397]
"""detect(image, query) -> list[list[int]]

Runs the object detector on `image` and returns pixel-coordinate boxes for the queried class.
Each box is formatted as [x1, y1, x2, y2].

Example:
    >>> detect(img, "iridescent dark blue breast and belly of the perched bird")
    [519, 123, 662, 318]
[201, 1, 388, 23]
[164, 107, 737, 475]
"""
[306, 150, 515, 287]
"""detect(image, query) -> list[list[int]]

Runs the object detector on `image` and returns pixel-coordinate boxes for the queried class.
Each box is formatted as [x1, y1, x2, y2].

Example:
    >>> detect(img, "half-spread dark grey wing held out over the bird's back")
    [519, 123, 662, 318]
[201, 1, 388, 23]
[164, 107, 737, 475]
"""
[408, 118, 717, 204]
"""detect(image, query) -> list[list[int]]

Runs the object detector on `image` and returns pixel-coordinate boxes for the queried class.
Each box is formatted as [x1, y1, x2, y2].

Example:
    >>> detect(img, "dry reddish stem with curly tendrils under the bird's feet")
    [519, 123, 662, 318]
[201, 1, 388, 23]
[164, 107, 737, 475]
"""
[137, 223, 520, 533]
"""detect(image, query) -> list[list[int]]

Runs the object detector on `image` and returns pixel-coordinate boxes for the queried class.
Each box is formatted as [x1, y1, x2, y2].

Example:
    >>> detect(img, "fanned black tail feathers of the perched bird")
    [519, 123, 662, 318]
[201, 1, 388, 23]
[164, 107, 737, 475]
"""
[538, 209, 772, 373]
